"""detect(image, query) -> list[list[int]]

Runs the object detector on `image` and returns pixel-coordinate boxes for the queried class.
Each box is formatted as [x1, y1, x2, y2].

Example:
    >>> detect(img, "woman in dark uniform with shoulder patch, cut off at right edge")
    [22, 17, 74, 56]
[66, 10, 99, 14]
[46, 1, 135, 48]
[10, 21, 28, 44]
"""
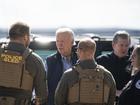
[119, 45, 140, 105]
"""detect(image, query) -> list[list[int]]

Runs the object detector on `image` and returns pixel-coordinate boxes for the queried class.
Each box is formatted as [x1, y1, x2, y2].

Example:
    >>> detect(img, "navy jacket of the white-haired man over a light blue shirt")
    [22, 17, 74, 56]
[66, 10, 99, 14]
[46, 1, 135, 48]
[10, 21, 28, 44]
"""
[46, 47, 77, 105]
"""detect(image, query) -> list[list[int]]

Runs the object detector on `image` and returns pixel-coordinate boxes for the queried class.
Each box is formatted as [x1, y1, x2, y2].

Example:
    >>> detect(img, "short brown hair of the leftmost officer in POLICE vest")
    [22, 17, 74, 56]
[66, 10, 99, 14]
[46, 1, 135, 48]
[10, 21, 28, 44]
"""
[9, 22, 30, 39]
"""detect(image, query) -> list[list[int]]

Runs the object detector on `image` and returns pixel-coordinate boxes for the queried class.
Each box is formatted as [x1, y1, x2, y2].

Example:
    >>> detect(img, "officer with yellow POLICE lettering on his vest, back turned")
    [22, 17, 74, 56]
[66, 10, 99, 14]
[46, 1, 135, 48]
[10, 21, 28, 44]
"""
[0, 22, 47, 105]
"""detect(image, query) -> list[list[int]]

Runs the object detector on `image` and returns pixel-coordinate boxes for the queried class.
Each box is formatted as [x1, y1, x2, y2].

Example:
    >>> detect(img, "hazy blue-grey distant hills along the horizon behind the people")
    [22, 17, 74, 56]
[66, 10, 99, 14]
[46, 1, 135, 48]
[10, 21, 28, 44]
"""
[0, 28, 140, 37]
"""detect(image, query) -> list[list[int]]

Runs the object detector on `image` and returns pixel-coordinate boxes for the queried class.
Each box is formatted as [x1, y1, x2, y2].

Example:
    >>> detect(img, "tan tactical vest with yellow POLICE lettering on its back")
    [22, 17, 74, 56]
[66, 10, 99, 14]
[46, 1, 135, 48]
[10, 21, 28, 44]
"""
[0, 48, 33, 105]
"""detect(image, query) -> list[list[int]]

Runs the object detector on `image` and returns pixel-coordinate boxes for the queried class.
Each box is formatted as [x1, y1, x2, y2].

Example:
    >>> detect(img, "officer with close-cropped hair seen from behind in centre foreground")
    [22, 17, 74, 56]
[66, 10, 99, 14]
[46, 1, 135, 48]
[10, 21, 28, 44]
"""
[55, 38, 116, 105]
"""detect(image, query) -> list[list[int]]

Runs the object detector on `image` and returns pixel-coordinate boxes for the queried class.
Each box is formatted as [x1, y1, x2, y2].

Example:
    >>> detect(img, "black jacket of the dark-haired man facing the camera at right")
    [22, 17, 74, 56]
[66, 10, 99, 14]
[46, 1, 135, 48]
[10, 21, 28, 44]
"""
[96, 52, 131, 90]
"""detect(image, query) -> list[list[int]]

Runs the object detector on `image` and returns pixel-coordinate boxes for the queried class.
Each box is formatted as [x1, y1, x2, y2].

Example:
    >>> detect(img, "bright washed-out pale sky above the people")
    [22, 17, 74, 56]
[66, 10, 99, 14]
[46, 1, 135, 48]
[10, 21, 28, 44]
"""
[0, 0, 140, 29]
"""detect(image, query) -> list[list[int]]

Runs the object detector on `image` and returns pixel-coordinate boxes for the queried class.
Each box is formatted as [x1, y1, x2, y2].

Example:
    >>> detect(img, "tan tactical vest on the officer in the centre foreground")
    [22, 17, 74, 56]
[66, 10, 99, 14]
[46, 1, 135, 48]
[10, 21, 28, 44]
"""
[68, 65, 109, 104]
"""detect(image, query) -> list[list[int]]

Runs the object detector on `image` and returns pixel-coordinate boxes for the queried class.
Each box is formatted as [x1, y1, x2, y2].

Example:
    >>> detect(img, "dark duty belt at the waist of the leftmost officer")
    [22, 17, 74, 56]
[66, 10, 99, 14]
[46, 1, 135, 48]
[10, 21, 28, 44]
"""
[0, 86, 32, 105]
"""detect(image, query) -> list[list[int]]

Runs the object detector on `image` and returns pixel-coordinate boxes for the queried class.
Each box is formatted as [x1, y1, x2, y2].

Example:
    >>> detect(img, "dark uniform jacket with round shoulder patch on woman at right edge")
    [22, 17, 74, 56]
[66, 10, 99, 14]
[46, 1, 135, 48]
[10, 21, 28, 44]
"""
[119, 71, 140, 105]
